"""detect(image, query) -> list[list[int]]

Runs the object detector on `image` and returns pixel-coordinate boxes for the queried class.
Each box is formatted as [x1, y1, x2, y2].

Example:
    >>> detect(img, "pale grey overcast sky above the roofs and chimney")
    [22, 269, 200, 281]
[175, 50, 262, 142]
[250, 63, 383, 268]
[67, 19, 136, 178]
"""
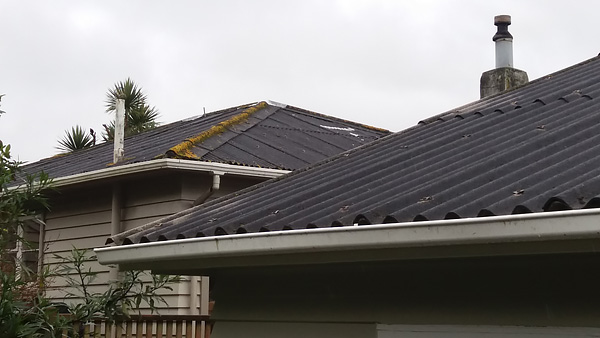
[0, 0, 600, 161]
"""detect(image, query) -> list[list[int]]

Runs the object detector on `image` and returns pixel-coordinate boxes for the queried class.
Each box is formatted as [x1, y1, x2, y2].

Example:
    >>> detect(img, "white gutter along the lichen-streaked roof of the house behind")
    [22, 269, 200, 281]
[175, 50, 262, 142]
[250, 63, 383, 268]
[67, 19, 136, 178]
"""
[47, 158, 290, 187]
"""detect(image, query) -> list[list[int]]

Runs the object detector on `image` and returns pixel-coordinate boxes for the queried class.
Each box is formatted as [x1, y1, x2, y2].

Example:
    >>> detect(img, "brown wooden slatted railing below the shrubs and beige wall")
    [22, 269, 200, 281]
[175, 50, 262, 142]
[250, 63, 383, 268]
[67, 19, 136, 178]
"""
[63, 315, 212, 338]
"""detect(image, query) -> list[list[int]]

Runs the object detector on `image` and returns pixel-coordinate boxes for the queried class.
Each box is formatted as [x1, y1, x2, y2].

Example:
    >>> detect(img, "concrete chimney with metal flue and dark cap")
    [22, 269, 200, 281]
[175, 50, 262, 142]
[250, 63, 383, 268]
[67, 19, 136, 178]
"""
[479, 15, 529, 98]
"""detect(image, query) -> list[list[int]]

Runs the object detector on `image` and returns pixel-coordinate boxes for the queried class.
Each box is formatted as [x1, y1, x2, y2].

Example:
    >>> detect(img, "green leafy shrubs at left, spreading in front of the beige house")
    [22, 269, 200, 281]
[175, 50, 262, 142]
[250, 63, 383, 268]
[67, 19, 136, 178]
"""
[0, 134, 179, 338]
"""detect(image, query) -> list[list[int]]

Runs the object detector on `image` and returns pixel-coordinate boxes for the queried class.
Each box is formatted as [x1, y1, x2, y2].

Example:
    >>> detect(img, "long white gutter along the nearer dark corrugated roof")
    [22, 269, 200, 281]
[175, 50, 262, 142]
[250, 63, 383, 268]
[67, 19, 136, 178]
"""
[94, 209, 600, 270]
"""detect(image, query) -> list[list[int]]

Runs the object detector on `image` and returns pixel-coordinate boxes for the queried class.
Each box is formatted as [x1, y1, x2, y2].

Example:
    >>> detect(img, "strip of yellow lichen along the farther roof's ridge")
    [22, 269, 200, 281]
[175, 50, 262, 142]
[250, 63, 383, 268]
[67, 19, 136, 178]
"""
[169, 101, 267, 159]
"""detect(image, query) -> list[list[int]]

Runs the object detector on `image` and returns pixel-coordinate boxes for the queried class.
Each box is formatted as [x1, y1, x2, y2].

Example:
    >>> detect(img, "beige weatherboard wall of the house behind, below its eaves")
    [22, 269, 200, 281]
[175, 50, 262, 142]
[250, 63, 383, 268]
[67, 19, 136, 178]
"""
[43, 172, 272, 314]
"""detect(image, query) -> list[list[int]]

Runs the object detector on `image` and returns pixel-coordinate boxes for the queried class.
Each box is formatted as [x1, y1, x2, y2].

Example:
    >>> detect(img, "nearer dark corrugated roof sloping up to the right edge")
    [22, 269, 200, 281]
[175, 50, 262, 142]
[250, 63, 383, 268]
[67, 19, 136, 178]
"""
[113, 57, 600, 244]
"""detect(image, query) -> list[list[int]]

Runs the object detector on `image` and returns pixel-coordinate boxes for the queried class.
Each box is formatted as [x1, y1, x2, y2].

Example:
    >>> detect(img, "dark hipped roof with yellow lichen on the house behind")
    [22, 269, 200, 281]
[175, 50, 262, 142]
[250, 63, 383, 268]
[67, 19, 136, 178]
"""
[18, 101, 389, 182]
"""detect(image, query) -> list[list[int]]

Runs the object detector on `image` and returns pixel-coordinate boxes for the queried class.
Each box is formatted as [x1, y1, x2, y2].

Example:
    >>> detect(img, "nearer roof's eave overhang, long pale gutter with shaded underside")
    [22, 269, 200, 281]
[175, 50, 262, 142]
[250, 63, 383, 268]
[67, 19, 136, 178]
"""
[95, 209, 600, 274]
